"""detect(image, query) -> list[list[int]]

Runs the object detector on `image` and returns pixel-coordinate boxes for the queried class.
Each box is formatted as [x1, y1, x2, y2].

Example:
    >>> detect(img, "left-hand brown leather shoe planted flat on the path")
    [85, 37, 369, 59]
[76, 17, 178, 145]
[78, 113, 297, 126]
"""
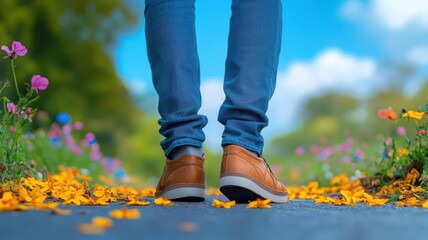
[155, 155, 205, 201]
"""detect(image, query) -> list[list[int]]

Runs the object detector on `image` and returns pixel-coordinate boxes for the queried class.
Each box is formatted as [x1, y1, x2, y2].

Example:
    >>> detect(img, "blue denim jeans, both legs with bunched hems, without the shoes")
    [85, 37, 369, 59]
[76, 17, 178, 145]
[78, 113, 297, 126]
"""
[145, 0, 282, 156]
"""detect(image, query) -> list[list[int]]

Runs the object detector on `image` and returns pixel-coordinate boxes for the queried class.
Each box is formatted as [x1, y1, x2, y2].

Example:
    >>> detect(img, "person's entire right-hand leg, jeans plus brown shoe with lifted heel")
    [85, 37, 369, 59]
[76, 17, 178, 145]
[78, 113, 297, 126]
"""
[219, 0, 288, 203]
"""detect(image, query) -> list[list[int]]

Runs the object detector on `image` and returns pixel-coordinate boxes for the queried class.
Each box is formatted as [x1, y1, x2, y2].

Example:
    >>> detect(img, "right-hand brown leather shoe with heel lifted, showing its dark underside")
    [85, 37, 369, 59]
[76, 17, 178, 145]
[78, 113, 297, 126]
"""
[220, 145, 288, 203]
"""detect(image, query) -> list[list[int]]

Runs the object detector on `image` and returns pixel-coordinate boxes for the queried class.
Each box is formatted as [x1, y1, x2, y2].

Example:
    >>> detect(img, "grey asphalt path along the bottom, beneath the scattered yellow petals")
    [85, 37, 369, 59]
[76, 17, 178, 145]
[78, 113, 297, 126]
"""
[0, 197, 428, 240]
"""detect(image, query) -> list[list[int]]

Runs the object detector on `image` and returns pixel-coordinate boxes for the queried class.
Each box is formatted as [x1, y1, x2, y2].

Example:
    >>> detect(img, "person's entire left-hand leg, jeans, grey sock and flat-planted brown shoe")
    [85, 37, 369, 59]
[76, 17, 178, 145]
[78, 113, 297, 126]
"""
[145, 0, 207, 201]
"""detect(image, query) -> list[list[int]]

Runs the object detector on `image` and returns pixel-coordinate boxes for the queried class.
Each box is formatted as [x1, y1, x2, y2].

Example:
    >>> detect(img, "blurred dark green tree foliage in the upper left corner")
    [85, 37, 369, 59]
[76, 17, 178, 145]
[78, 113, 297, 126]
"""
[0, 0, 142, 154]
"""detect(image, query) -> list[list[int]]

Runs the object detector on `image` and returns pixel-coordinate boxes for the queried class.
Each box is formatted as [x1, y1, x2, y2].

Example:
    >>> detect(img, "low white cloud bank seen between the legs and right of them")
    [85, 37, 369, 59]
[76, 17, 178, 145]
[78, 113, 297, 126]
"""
[200, 49, 379, 150]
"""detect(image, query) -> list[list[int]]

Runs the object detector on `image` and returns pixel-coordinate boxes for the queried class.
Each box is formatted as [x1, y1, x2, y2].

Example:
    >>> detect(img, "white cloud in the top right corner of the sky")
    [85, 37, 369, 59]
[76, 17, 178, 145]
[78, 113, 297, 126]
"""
[339, 0, 428, 31]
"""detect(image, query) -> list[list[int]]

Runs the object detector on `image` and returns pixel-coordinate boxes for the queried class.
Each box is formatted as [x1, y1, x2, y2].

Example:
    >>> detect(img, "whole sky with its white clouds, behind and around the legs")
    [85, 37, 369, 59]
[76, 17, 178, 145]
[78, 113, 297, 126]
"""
[114, 0, 428, 150]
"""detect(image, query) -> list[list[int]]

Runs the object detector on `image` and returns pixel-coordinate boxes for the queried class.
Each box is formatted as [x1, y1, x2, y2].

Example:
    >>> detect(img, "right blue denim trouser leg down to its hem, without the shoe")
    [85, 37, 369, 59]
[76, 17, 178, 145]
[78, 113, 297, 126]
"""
[218, 0, 282, 155]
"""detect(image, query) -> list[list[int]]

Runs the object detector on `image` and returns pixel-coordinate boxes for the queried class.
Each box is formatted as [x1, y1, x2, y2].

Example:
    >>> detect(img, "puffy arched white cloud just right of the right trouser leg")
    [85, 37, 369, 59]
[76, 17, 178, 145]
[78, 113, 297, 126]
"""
[265, 49, 382, 137]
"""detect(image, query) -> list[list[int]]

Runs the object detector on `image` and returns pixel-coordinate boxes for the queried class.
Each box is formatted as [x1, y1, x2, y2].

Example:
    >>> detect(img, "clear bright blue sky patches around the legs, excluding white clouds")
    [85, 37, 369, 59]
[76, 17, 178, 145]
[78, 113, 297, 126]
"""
[116, 0, 379, 84]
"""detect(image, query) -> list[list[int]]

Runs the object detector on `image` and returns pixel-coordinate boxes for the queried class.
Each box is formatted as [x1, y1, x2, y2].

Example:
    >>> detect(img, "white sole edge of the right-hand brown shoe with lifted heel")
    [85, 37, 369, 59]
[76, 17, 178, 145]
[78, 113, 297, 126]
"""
[220, 176, 288, 203]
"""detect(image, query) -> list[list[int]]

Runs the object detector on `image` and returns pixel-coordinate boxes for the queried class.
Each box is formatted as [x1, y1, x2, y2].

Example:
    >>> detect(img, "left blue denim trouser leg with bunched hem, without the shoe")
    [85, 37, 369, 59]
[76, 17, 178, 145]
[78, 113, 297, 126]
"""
[144, 0, 207, 157]
